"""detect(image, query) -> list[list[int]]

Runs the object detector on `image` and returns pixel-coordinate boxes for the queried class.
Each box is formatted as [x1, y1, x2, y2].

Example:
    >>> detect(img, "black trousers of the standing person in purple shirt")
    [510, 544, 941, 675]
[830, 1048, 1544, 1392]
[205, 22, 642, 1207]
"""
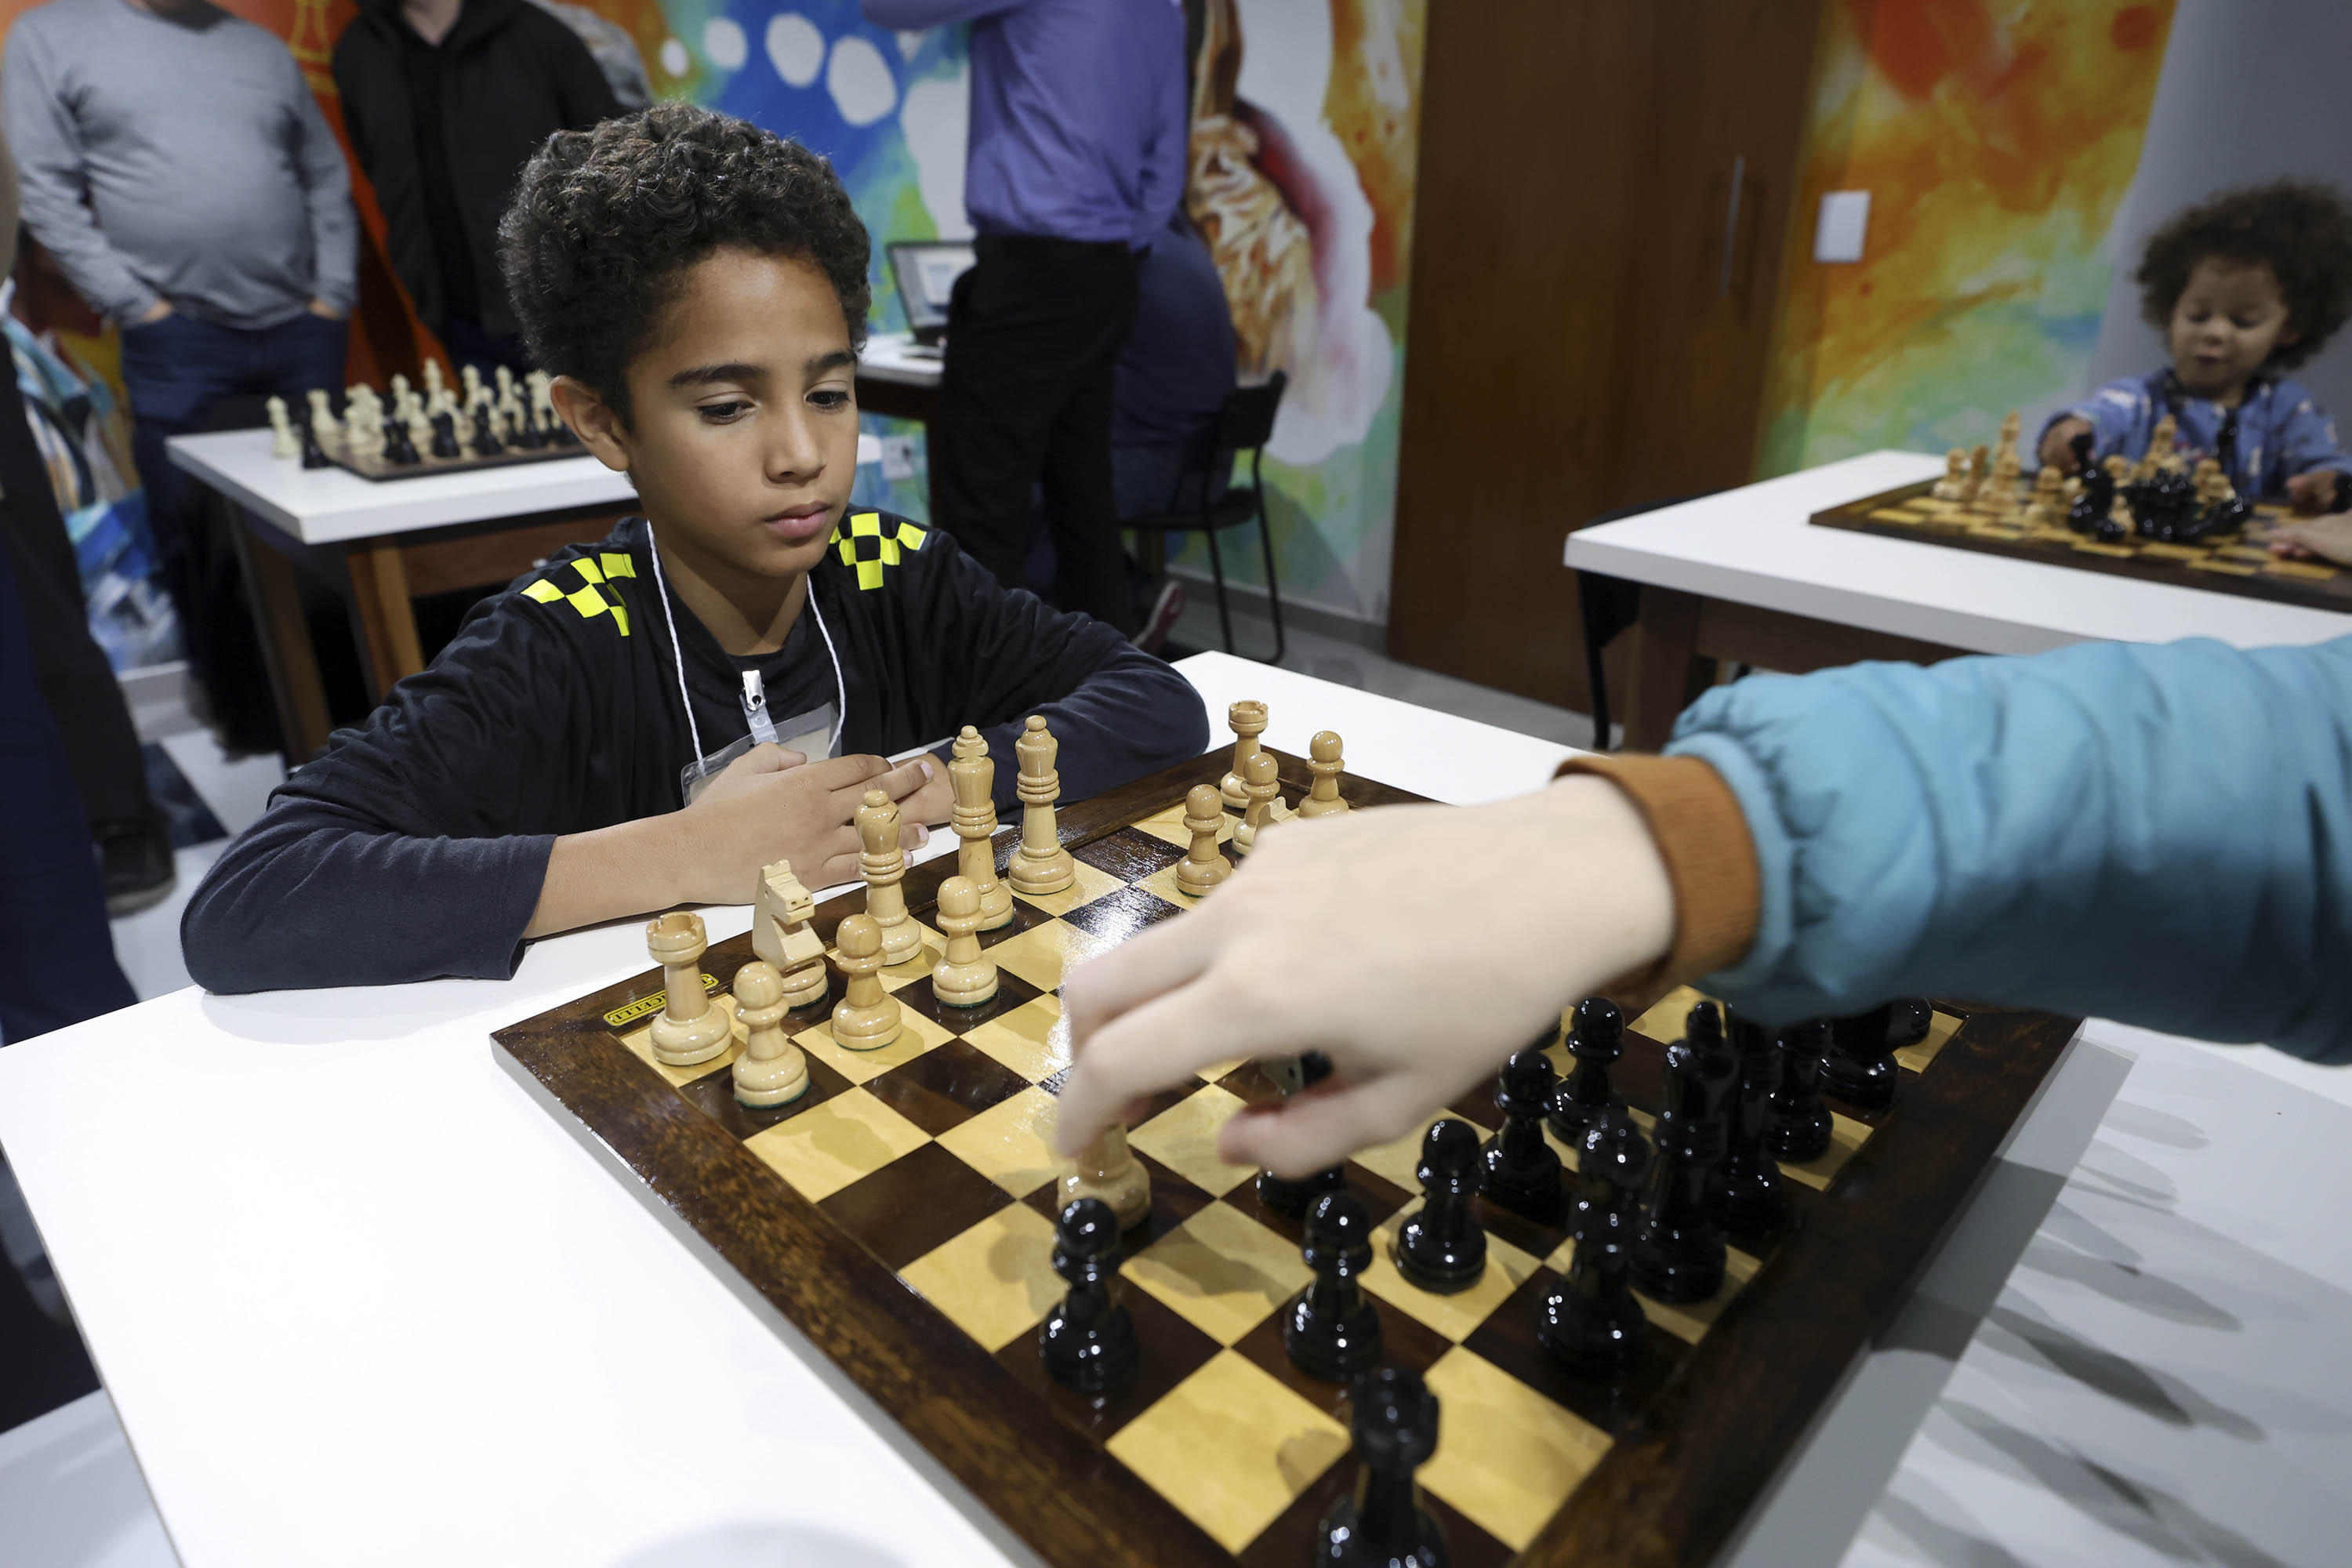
[931, 235, 1138, 637]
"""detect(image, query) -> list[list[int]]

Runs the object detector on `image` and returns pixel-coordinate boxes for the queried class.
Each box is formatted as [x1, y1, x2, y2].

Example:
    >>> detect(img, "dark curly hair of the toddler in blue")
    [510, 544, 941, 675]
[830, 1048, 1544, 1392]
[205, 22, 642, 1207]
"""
[2136, 179, 2352, 369]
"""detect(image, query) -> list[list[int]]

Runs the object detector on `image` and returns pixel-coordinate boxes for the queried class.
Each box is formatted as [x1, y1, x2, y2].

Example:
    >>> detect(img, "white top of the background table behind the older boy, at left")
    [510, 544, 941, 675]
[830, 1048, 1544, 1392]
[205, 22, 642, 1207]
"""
[165, 430, 882, 546]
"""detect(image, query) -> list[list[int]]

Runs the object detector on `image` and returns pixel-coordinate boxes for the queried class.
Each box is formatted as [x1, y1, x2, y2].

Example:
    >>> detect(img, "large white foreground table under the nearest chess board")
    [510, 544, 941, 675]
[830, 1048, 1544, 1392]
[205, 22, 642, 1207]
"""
[0, 654, 2352, 1568]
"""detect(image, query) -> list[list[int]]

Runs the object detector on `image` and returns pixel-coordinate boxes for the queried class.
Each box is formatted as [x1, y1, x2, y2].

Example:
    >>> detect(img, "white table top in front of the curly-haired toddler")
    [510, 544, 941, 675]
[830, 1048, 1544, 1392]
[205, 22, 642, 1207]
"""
[1564, 452, 2352, 654]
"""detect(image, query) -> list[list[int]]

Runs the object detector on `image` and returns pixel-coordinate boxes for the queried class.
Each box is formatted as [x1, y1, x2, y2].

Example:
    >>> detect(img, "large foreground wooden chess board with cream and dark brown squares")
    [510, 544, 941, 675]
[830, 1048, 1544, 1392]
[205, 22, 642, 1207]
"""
[496, 755, 2074, 1568]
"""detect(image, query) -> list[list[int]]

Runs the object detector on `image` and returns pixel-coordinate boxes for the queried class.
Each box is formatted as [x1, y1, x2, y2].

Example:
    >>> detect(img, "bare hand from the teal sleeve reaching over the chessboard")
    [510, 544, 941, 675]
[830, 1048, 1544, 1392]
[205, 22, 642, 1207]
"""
[1054, 776, 1675, 1175]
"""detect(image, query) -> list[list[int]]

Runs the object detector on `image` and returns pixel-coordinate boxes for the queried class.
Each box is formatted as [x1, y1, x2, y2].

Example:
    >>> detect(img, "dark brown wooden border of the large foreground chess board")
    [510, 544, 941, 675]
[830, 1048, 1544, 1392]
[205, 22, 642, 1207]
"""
[494, 748, 2077, 1568]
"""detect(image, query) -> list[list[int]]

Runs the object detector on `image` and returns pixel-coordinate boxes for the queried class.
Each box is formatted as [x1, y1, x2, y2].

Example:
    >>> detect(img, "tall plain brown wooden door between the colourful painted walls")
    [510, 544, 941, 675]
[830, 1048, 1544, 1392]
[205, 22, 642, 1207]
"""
[1388, 0, 1818, 708]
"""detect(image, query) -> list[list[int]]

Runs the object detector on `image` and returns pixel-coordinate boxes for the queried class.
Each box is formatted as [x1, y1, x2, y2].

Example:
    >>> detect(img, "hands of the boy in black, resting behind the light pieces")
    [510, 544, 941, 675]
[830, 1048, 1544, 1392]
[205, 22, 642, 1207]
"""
[663, 746, 943, 902]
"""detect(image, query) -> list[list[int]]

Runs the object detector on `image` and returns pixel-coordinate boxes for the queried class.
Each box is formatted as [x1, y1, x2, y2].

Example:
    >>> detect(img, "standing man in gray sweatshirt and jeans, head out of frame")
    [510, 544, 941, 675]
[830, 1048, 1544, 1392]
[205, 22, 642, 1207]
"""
[0, 0, 360, 750]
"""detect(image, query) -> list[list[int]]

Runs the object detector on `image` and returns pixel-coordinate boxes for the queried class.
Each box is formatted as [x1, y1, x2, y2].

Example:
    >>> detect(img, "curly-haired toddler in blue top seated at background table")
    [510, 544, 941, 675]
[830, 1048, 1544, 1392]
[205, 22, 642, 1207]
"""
[2042, 181, 2352, 513]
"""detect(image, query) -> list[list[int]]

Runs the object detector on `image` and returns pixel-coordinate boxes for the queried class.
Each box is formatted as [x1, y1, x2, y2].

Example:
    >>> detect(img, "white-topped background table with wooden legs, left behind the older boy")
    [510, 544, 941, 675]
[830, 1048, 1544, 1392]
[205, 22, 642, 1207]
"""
[167, 430, 882, 762]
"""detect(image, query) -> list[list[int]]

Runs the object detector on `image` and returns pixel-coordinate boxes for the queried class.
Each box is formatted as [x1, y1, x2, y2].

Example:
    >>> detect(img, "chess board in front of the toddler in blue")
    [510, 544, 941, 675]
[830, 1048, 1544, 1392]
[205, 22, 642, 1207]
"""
[1811, 480, 2352, 614]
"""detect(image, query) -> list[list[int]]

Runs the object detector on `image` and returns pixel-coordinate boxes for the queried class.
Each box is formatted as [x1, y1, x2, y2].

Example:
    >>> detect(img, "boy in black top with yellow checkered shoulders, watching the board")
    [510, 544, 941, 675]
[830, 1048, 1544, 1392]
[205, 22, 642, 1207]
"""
[181, 103, 1209, 992]
